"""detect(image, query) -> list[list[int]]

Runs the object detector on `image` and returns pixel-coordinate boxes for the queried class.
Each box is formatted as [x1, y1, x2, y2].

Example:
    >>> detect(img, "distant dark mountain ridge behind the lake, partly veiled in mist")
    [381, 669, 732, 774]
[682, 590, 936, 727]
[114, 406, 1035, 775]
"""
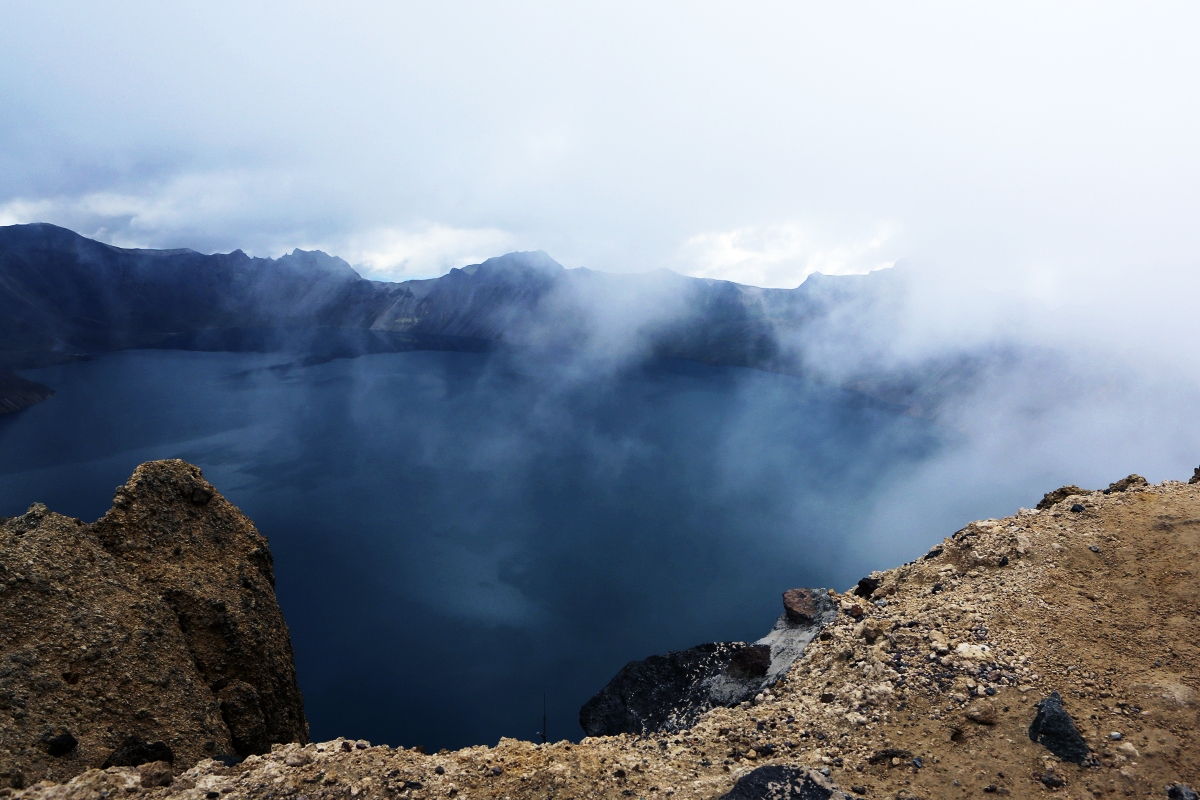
[0, 223, 968, 413]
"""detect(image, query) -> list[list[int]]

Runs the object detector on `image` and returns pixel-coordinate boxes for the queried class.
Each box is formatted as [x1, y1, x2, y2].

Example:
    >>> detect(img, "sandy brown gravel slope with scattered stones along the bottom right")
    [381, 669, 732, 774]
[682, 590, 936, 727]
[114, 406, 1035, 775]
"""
[9, 465, 1200, 800]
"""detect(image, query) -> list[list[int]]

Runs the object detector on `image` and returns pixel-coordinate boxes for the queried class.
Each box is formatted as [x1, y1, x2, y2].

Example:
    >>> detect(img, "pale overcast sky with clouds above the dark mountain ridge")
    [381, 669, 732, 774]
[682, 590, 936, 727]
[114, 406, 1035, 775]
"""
[0, 0, 1200, 297]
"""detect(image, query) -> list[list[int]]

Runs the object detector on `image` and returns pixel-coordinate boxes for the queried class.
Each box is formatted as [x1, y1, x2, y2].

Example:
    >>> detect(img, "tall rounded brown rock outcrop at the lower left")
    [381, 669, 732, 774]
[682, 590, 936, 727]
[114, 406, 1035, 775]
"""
[0, 461, 307, 788]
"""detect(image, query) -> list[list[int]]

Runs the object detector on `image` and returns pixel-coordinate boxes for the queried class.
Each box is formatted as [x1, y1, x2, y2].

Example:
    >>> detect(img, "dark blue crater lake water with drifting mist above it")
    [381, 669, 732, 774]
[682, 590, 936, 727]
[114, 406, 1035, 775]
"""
[0, 351, 949, 748]
